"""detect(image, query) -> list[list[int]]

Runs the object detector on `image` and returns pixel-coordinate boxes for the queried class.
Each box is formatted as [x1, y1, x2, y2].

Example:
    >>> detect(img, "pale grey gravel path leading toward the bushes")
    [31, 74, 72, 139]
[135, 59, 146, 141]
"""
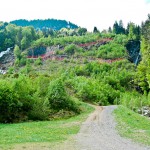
[74, 106, 150, 150]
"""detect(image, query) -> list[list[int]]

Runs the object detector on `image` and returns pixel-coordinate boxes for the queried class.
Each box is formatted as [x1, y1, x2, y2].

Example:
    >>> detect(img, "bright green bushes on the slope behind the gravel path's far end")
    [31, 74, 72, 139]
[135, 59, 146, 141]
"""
[63, 60, 135, 105]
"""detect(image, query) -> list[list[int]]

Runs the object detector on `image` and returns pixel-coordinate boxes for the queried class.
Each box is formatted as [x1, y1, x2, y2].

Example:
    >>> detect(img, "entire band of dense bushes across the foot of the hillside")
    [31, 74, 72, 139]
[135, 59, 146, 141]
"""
[0, 56, 139, 122]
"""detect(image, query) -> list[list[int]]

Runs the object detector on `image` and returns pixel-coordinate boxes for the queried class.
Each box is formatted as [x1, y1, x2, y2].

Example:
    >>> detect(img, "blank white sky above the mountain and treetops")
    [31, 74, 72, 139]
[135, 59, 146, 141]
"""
[0, 0, 150, 31]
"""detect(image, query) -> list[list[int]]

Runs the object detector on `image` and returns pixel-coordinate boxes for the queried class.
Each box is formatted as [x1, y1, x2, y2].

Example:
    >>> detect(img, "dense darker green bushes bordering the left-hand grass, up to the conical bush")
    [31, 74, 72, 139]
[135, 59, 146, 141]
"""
[0, 75, 80, 123]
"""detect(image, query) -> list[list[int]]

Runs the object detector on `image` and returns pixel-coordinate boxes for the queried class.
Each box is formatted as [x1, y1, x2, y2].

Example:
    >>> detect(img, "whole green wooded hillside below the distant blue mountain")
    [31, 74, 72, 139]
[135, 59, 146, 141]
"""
[0, 18, 150, 123]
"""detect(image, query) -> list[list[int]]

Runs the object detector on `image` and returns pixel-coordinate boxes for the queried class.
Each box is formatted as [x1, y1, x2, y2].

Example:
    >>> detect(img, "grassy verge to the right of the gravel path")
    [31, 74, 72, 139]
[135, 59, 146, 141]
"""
[114, 106, 150, 145]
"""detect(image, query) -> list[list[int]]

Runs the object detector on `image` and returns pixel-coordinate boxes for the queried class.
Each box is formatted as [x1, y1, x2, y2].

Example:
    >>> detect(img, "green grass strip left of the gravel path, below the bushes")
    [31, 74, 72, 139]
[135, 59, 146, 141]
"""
[0, 103, 94, 149]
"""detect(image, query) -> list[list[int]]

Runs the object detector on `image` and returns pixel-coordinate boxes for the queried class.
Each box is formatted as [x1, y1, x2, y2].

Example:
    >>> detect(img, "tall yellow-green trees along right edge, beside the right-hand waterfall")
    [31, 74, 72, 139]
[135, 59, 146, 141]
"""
[136, 14, 150, 94]
